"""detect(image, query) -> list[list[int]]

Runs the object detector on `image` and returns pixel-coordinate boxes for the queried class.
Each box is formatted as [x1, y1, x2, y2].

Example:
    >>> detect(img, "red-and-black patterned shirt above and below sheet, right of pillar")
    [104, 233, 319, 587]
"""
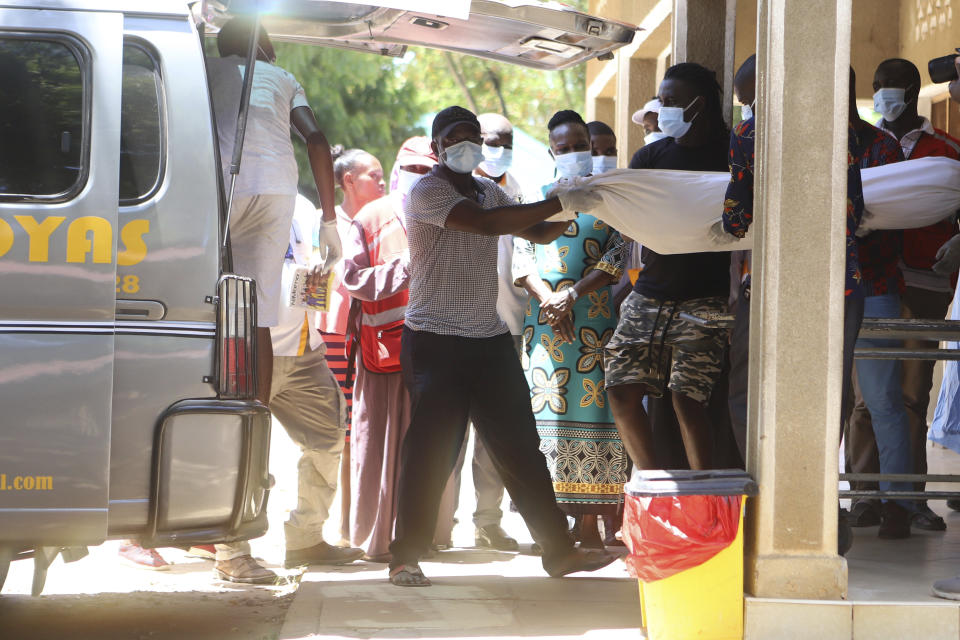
[857, 123, 905, 296]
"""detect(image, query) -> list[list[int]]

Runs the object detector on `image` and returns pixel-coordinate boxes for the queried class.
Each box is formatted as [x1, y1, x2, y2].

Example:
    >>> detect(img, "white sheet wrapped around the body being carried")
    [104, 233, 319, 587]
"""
[575, 158, 960, 254]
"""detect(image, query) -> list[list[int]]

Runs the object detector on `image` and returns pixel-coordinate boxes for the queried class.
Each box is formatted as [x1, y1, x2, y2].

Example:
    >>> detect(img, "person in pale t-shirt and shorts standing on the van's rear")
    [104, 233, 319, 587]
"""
[207, 18, 341, 582]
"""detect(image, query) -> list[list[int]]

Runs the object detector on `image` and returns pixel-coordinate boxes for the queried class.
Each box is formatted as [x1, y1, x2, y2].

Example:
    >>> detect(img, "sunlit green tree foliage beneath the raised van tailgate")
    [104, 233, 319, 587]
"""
[276, 0, 586, 195]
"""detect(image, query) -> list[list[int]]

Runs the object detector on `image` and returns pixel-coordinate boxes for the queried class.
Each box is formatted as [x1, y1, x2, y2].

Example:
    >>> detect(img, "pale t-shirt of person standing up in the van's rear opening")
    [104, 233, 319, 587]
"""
[207, 56, 310, 197]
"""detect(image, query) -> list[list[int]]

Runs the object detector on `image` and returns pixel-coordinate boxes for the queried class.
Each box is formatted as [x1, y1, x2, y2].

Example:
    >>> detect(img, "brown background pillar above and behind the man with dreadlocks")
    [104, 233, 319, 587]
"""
[673, 0, 737, 125]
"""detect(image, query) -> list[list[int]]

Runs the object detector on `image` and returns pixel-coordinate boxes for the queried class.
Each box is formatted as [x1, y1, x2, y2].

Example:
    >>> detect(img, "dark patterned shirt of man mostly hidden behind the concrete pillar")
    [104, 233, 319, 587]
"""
[723, 118, 863, 296]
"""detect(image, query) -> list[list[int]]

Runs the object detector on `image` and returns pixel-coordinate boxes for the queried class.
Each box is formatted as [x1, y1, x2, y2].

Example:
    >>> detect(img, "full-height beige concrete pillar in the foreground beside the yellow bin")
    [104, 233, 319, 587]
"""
[745, 0, 851, 599]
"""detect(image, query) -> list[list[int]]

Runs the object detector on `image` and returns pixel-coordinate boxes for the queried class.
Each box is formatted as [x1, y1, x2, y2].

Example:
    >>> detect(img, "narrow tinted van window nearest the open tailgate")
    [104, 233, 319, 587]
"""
[120, 41, 163, 205]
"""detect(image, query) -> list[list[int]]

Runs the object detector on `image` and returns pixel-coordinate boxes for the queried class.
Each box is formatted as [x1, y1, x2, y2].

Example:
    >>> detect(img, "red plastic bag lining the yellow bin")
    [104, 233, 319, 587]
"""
[622, 495, 741, 582]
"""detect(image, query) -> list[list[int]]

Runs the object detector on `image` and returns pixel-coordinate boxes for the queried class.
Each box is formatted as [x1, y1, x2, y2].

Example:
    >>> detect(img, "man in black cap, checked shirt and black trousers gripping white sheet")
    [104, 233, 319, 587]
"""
[390, 107, 612, 586]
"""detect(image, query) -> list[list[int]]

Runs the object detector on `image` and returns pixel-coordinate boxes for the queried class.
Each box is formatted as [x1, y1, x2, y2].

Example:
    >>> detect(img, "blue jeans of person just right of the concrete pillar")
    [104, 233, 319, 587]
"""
[857, 293, 914, 509]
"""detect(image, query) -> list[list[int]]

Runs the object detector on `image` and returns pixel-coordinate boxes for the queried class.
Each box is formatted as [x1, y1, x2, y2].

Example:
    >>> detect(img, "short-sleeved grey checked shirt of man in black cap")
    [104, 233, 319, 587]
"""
[404, 166, 516, 338]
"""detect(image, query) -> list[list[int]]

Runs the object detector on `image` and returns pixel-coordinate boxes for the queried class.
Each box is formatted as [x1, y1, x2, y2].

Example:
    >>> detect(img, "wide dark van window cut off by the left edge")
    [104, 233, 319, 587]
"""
[0, 34, 86, 200]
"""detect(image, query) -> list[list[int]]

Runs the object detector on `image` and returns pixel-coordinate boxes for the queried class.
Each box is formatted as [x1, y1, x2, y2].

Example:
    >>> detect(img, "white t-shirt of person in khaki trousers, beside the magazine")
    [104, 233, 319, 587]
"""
[270, 195, 324, 356]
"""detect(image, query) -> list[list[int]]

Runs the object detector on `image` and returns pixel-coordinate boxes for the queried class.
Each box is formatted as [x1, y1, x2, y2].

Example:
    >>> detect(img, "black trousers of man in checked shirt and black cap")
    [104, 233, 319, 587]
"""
[390, 327, 573, 568]
